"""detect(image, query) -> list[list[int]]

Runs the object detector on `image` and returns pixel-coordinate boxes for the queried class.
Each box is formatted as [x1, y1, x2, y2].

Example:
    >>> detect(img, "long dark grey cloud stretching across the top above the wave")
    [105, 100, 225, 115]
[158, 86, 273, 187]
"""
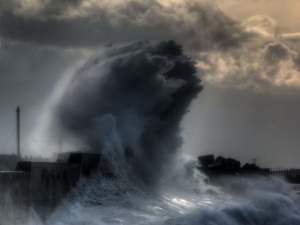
[0, 0, 253, 50]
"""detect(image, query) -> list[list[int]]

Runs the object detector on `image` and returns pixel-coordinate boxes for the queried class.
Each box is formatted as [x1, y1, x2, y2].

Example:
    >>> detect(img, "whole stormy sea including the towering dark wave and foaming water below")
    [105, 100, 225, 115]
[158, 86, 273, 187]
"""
[30, 41, 300, 225]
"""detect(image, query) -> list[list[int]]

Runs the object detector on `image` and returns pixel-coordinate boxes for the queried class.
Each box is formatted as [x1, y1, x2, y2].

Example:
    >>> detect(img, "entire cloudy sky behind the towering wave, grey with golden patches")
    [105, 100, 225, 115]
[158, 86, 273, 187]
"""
[0, 0, 300, 167]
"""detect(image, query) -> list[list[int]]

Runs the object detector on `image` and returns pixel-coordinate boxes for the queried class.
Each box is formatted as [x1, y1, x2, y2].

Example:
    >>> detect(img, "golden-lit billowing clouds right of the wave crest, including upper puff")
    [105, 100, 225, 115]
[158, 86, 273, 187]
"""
[188, 11, 300, 93]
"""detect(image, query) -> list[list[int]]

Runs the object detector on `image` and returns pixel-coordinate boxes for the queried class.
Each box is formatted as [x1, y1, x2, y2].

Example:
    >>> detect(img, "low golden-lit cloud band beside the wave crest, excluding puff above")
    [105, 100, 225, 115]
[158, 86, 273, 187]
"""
[198, 41, 300, 93]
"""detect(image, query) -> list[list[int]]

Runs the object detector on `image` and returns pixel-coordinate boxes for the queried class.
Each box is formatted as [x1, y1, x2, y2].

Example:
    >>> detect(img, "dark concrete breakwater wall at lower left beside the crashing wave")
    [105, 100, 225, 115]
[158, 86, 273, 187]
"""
[0, 153, 101, 225]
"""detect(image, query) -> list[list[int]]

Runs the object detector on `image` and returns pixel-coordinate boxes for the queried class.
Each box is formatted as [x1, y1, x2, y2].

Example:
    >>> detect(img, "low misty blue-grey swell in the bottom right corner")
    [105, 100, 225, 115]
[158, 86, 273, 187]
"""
[163, 177, 300, 225]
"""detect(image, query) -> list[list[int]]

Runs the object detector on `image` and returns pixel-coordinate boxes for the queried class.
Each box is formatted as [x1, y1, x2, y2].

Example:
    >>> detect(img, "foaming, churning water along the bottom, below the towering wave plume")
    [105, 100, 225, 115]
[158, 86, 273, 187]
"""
[42, 158, 300, 225]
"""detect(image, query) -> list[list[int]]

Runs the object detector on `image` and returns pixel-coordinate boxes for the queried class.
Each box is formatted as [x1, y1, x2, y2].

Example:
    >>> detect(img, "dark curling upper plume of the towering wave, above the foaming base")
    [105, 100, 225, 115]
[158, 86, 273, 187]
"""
[57, 41, 202, 185]
